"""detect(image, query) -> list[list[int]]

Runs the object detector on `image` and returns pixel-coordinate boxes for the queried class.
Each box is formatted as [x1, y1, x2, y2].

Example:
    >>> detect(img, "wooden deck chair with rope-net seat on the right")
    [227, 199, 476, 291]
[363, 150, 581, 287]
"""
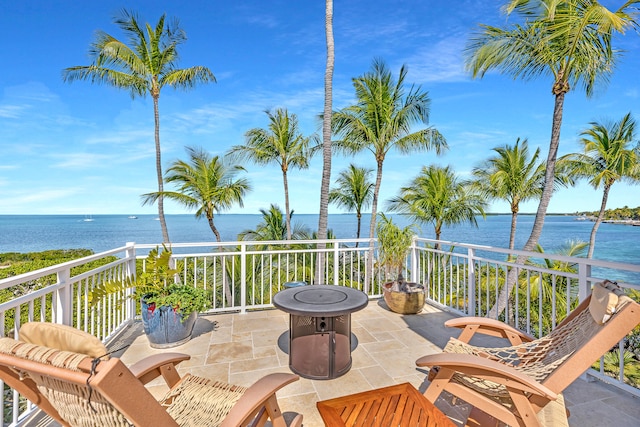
[416, 281, 640, 427]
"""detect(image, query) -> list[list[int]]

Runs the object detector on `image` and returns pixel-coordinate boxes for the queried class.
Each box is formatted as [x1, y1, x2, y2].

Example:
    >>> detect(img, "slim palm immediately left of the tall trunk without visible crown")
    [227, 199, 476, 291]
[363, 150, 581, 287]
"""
[230, 108, 312, 240]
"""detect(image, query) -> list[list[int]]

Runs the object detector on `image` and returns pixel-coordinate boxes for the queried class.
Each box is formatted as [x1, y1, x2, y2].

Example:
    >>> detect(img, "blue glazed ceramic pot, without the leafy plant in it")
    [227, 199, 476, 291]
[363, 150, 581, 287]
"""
[141, 300, 198, 348]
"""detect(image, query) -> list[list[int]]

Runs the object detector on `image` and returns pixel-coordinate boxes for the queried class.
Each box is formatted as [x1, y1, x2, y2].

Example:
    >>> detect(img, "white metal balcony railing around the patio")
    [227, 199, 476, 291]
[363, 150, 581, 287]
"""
[0, 238, 640, 425]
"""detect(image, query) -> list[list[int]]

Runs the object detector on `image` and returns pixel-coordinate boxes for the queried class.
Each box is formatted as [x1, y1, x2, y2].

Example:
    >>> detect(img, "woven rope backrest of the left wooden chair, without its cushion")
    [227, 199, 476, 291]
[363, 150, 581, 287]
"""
[0, 338, 178, 427]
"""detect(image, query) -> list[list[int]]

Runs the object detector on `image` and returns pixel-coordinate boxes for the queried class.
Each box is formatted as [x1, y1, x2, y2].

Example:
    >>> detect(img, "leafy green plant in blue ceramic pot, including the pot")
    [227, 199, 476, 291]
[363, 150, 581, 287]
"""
[89, 245, 208, 348]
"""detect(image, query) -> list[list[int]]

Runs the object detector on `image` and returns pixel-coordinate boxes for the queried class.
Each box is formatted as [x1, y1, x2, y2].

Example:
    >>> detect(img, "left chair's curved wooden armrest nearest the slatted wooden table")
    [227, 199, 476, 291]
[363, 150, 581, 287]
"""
[221, 373, 302, 427]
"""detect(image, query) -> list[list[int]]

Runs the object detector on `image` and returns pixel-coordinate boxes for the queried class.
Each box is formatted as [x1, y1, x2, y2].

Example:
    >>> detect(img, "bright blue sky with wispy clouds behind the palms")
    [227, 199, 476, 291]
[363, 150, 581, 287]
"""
[0, 0, 640, 214]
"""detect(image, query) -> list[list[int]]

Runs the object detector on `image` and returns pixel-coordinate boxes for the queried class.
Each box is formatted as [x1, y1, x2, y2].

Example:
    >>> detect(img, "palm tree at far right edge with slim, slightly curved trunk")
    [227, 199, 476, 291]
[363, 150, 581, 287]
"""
[558, 113, 640, 259]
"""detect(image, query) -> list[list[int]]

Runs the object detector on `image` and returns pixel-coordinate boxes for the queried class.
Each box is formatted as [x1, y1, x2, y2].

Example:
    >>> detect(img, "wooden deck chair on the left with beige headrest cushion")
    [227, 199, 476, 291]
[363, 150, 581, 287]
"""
[0, 323, 302, 427]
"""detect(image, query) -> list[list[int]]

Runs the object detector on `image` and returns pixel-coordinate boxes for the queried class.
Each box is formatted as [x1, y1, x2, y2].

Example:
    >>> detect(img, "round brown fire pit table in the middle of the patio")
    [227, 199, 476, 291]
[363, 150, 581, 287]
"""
[273, 285, 369, 380]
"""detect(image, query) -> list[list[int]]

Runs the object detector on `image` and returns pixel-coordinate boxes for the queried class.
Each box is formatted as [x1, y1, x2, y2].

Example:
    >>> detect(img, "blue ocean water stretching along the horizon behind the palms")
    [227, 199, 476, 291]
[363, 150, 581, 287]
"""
[0, 214, 640, 270]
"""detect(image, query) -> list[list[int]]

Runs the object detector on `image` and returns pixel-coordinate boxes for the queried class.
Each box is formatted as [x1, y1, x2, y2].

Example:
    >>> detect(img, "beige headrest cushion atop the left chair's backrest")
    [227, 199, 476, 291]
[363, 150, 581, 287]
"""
[18, 322, 108, 359]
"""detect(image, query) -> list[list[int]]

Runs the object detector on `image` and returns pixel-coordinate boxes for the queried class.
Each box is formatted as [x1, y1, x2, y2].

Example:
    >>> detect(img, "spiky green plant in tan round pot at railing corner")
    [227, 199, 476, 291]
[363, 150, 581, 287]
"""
[376, 213, 425, 314]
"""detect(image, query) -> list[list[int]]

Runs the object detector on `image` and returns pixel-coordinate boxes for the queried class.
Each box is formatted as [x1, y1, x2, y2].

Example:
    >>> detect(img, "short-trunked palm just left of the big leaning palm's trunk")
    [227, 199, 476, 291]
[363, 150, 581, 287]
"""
[472, 138, 545, 249]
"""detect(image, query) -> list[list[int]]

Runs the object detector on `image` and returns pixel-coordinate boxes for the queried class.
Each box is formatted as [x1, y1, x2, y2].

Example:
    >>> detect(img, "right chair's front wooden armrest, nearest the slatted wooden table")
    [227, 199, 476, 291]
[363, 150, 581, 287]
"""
[416, 353, 558, 400]
